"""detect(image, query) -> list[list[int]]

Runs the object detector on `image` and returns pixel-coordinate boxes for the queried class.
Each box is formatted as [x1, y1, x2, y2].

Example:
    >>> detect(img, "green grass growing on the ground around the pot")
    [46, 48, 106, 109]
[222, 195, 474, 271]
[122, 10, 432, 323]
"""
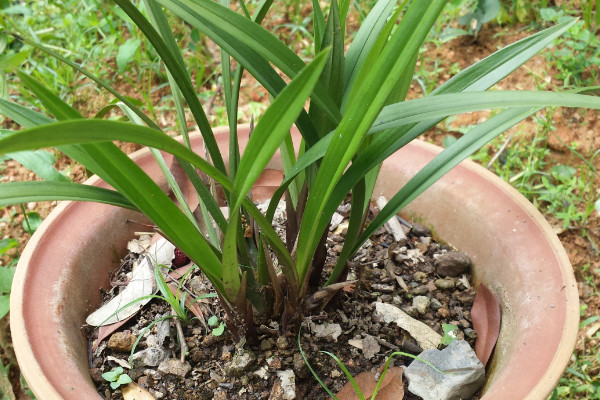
[0, 0, 600, 399]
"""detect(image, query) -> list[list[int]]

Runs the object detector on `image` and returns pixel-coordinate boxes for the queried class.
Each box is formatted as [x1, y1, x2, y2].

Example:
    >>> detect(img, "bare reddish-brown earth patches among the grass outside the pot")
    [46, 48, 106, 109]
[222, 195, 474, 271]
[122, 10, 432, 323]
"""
[0, 21, 600, 398]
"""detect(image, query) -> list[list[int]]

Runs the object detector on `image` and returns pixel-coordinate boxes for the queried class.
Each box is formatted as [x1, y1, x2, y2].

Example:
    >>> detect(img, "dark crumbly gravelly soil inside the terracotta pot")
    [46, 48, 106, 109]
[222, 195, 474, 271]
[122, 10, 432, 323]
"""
[89, 209, 476, 400]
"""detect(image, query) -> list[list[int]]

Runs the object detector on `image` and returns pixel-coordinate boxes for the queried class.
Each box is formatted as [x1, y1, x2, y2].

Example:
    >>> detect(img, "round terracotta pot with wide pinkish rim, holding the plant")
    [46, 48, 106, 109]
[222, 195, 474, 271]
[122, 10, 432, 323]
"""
[11, 127, 579, 400]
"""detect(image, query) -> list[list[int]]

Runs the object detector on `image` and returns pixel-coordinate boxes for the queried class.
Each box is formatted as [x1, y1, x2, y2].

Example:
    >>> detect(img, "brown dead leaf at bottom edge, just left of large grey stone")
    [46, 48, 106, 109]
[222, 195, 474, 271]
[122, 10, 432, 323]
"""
[337, 367, 404, 400]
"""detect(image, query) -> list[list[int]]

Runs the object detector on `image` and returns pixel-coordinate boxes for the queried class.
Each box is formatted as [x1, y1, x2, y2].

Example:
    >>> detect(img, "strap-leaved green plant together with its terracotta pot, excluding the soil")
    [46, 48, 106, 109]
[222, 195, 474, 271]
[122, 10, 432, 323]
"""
[0, 0, 600, 399]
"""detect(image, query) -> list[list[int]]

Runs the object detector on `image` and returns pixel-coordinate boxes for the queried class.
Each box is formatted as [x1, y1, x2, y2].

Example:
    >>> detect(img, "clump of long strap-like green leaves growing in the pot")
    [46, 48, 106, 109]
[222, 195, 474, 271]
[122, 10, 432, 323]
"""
[0, 0, 600, 342]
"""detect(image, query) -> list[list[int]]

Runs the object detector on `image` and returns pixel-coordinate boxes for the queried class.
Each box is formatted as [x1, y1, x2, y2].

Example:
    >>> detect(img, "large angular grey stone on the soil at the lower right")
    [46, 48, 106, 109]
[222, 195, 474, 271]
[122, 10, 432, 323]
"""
[404, 340, 485, 400]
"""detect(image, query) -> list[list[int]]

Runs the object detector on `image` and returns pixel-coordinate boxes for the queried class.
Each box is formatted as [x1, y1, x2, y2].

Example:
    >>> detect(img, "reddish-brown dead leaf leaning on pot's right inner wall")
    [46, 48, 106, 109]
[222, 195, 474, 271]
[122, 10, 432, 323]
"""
[471, 283, 501, 366]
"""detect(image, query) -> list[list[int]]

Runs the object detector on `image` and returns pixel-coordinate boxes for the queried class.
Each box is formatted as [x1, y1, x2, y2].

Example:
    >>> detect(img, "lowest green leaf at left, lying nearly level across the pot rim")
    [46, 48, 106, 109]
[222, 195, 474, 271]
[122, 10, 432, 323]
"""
[0, 181, 137, 210]
